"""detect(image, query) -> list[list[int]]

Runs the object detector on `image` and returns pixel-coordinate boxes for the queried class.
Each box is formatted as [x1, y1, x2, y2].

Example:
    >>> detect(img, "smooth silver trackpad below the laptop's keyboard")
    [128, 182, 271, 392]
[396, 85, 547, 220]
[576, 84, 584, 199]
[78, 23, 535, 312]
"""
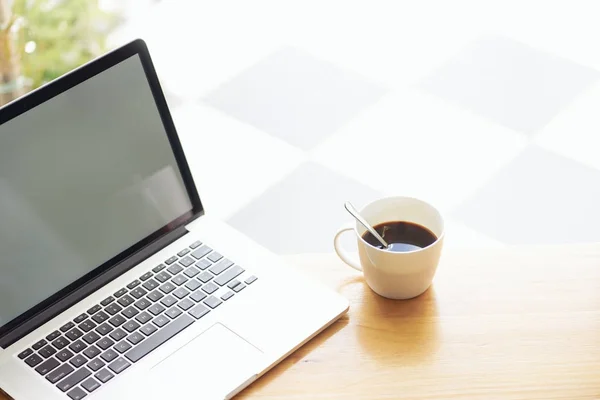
[145, 324, 262, 400]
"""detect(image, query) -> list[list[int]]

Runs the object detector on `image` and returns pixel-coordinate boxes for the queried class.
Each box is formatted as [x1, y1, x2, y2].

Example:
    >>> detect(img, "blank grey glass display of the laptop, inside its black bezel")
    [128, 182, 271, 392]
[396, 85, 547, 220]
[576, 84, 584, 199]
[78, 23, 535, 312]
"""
[0, 55, 192, 328]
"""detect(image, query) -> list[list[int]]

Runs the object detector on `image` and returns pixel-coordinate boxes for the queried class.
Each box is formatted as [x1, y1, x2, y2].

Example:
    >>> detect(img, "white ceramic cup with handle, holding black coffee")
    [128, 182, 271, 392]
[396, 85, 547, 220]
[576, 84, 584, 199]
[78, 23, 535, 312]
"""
[334, 197, 444, 299]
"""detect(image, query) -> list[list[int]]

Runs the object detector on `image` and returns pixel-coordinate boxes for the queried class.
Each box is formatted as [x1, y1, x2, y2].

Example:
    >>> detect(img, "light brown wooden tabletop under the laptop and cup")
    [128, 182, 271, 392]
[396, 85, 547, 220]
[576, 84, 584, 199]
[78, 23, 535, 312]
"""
[0, 245, 600, 400]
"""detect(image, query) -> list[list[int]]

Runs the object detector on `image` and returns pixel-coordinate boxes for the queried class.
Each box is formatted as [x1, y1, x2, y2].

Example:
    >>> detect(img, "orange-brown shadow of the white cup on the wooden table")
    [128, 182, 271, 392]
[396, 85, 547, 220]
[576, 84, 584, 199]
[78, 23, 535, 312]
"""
[351, 283, 441, 365]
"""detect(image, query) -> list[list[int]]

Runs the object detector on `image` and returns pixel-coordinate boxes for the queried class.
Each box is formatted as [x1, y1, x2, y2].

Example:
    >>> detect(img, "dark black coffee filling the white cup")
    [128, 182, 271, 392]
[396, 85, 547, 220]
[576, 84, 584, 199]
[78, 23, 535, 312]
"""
[363, 221, 437, 253]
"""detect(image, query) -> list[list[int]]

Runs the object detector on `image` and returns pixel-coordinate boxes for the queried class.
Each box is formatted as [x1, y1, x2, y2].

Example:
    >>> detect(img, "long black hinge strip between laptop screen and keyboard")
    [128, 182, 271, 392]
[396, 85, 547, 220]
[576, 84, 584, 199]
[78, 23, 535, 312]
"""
[0, 226, 189, 349]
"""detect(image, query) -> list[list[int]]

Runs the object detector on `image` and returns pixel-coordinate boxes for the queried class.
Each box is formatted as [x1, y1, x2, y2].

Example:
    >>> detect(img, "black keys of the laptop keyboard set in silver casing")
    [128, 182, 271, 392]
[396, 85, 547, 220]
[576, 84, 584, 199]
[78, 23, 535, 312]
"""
[18, 241, 257, 400]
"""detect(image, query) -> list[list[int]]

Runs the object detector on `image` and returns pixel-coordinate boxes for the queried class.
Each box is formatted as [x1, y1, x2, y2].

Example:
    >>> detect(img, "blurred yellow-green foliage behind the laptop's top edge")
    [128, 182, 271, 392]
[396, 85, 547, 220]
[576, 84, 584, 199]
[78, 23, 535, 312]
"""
[13, 0, 119, 89]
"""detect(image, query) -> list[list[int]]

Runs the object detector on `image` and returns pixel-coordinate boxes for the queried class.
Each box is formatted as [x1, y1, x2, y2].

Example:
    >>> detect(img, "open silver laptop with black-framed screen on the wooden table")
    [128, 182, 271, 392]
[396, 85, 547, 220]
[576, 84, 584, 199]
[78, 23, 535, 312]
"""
[0, 40, 348, 400]
